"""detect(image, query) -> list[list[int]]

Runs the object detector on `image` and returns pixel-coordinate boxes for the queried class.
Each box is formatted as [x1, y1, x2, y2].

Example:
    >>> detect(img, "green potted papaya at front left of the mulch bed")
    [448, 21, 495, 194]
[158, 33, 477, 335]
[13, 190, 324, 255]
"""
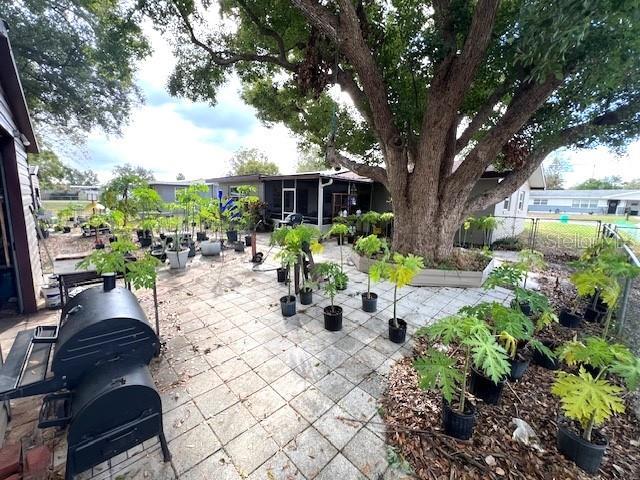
[414, 313, 509, 440]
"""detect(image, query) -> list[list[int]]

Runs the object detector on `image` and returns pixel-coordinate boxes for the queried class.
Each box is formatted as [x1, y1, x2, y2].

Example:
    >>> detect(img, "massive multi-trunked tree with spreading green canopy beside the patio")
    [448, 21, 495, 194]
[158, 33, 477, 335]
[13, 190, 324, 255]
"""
[142, 0, 640, 258]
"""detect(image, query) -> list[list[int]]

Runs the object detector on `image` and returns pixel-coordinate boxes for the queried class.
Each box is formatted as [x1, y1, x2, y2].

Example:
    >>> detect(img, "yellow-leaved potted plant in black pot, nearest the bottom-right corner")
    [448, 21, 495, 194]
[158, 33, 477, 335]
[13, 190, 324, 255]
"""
[551, 344, 640, 473]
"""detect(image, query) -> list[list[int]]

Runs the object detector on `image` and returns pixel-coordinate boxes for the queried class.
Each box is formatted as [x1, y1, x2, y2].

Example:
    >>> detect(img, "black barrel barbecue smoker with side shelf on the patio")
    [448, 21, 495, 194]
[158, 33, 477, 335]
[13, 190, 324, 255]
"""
[0, 277, 170, 480]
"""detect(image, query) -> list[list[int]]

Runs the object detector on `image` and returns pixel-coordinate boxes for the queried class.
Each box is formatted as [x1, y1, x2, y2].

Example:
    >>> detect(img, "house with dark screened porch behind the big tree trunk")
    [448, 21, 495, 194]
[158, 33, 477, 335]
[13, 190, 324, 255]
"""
[150, 163, 544, 234]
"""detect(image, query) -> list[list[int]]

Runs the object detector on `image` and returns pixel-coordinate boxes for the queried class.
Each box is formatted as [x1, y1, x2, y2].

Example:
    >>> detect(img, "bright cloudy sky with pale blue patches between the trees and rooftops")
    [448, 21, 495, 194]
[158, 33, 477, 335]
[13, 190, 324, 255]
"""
[63, 23, 640, 188]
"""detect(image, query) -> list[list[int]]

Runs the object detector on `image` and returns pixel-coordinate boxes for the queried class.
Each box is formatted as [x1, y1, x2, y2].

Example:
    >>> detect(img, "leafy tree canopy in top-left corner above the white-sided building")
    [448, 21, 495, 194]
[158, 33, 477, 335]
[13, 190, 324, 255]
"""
[0, 0, 150, 133]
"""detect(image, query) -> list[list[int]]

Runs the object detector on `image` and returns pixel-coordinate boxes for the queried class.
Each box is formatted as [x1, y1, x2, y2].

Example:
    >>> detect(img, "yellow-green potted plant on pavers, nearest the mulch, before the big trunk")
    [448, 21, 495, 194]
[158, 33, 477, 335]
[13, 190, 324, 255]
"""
[380, 253, 424, 343]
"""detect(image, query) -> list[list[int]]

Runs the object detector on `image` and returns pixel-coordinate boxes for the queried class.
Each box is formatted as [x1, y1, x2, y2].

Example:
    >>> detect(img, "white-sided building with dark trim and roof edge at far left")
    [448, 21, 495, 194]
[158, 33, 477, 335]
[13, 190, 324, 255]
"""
[0, 20, 42, 313]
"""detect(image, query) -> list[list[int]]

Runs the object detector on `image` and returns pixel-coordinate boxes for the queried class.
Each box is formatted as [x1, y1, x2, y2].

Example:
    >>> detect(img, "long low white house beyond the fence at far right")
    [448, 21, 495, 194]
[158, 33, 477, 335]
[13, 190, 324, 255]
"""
[529, 190, 640, 215]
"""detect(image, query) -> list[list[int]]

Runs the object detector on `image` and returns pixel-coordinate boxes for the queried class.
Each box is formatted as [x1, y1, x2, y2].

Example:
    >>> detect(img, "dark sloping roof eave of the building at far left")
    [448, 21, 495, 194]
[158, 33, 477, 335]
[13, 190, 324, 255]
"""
[0, 19, 39, 153]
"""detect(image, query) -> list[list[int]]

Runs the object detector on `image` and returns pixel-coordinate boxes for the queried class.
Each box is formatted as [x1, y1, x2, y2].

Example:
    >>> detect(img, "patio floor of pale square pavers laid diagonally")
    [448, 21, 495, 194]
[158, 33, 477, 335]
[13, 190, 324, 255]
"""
[0, 237, 508, 480]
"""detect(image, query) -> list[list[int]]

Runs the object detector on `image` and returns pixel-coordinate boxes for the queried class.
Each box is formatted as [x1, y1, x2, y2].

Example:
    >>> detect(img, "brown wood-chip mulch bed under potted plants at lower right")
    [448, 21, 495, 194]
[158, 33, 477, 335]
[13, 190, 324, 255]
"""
[382, 325, 640, 480]
